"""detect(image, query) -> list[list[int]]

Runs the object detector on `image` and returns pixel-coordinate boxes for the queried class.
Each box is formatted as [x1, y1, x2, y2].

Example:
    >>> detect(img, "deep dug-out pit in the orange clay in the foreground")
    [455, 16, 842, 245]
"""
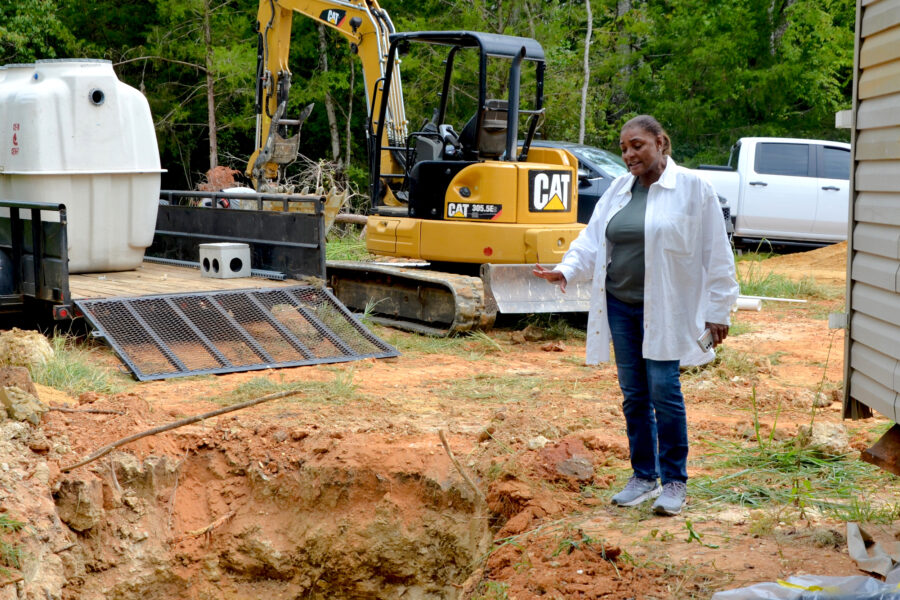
[43, 428, 492, 600]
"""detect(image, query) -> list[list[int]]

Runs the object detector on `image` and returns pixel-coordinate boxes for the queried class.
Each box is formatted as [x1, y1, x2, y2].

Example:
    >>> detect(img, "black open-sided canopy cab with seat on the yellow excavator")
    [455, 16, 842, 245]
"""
[369, 31, 545, 219]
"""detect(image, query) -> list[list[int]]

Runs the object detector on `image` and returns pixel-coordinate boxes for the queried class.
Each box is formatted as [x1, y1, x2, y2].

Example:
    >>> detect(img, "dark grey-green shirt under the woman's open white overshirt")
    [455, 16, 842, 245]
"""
[606, 179, 648, 304]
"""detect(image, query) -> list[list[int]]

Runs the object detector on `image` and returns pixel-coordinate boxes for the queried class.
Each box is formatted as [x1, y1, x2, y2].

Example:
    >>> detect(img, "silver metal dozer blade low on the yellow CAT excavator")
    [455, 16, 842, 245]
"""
[481, 264, 591, 314]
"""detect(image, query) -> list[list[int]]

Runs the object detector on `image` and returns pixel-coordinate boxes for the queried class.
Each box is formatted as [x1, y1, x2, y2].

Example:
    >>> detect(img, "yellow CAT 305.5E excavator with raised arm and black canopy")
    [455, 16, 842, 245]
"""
[247, 0, 587, 335]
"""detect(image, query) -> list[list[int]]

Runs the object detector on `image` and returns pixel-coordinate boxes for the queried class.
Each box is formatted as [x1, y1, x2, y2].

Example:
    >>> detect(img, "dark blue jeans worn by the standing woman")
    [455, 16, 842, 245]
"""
[606, 293, 688, 484]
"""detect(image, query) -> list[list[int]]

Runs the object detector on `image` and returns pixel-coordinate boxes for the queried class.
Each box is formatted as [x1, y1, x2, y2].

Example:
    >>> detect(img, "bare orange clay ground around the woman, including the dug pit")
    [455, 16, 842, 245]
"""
[8, 246, 900, 599]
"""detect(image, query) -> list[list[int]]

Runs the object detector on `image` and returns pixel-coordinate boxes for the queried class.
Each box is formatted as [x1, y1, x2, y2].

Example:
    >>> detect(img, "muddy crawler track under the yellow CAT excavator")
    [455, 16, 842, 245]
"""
[326, 261, 497, 336]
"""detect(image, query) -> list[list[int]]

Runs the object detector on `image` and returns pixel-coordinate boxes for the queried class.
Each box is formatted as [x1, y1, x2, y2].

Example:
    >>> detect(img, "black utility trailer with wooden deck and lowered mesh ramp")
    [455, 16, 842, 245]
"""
[0, 191, 397, 380]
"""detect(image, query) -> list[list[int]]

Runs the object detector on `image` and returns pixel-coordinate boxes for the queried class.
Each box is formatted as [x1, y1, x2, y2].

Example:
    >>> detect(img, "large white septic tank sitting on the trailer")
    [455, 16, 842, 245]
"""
[0, 59, 162, 273]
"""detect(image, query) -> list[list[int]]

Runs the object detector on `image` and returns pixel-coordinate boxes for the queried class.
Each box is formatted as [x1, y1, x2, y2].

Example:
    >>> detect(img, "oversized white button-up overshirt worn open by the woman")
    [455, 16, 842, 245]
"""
[554, 157, 738, 365]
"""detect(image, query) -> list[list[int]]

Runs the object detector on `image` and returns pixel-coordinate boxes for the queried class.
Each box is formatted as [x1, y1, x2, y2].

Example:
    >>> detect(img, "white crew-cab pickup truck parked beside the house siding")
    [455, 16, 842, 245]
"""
[697, 138, 850, 246]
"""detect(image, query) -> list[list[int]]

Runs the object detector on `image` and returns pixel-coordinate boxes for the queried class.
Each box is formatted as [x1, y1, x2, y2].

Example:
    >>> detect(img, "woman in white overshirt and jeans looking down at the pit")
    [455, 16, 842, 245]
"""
[534, 115, 738, 515]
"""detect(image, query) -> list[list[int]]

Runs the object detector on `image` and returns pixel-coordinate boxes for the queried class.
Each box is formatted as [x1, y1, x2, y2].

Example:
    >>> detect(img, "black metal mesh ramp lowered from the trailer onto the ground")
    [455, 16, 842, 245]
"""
[75, 286, 398, 381]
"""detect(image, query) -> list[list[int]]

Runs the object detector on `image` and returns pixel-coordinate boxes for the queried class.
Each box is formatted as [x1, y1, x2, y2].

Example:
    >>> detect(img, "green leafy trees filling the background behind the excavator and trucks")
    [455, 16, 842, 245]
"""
[0, 0, 855, 189]
